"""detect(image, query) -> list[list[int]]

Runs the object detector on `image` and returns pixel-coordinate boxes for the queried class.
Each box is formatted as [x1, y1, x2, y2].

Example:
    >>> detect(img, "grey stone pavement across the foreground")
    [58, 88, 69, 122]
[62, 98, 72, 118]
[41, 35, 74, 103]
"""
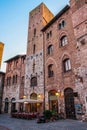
[0, 114, 87, 130]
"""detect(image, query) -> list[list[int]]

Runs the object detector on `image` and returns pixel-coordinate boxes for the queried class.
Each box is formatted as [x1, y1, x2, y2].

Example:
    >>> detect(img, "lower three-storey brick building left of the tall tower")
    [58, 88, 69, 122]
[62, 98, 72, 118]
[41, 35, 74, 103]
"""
[2, 55, 26, 113]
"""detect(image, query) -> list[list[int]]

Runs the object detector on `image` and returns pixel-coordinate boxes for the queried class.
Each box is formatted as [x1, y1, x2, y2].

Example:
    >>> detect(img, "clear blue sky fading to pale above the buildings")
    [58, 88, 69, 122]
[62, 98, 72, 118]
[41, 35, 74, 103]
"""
[0, 0, 69, 72]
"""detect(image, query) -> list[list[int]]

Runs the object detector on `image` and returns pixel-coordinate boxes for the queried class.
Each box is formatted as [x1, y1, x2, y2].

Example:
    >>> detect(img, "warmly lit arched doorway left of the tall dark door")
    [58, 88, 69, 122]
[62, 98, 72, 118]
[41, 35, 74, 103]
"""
[48, 90, 58, 113]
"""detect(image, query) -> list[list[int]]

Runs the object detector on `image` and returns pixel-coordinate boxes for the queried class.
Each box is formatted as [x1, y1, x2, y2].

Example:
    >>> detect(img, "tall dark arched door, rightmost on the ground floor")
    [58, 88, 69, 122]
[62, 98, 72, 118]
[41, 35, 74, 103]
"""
[64, 88, 76, 119]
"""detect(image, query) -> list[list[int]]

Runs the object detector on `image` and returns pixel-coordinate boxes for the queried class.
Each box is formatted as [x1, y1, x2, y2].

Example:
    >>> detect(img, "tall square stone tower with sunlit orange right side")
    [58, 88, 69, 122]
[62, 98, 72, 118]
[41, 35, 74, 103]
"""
[25, 3, 53, 110]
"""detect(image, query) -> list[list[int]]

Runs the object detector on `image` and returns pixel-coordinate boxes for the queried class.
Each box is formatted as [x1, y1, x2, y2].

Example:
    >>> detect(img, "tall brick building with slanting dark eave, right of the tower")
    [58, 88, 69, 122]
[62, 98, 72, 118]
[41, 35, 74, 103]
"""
[42, 3, 75, 118]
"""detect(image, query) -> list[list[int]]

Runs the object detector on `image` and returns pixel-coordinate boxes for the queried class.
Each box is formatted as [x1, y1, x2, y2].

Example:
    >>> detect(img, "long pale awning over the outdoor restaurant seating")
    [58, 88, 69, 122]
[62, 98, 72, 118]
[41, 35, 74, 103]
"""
[12, 99, 43, 103]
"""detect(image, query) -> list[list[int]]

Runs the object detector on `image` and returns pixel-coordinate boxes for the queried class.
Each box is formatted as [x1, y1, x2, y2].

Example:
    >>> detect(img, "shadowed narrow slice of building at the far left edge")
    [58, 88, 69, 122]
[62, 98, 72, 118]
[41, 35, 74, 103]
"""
[0, 71, 5, 113]
